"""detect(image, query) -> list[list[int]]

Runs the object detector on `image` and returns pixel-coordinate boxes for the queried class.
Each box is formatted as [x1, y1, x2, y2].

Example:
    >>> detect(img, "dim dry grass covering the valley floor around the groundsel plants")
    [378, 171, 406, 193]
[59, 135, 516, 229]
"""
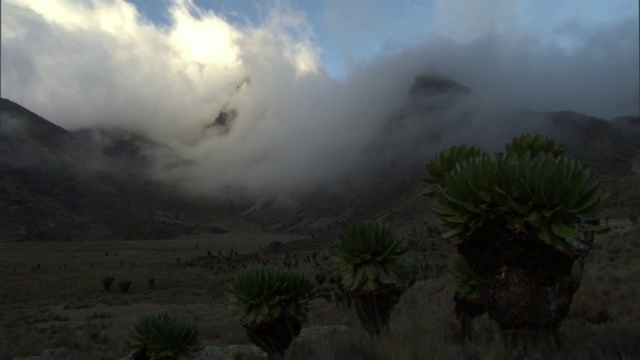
[0, 224, 640, 360]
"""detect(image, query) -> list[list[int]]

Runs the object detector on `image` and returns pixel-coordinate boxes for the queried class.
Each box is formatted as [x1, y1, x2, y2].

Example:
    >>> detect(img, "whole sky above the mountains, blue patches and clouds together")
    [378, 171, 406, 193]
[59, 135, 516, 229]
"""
[1, 0, 640, 195]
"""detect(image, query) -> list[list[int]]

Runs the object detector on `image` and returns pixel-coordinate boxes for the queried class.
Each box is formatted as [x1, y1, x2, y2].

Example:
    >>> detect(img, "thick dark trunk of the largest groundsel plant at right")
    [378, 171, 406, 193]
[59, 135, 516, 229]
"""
[458, 221, 579, 360]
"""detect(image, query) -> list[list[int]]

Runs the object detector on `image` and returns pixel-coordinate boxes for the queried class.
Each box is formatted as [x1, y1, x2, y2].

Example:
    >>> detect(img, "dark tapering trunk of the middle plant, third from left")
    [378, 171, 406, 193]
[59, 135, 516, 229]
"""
[354, 290, 402, 335]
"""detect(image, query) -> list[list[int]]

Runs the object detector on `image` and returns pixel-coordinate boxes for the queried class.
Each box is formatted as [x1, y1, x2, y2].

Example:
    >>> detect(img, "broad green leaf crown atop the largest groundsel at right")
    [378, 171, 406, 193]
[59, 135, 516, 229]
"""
[424, 135, 606, 252]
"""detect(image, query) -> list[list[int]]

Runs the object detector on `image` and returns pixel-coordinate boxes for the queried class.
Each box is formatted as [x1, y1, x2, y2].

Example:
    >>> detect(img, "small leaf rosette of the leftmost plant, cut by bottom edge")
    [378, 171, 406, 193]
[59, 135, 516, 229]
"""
[130, 311, 202, 360]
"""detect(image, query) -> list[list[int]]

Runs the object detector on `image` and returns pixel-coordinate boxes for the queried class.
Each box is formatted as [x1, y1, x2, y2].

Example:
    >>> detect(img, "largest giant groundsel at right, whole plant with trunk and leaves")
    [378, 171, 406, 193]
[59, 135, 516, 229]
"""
[424, 135, 606, 359]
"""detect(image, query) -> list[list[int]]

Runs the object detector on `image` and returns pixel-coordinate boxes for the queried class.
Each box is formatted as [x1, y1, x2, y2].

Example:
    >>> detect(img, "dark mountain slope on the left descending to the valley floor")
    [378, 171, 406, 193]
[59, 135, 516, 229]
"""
[0, 99, 222, 241]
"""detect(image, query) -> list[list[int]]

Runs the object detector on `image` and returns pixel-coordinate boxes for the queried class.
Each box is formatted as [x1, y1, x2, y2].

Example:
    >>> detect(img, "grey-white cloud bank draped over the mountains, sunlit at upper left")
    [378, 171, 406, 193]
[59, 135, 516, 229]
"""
[1, 0, 640, 194]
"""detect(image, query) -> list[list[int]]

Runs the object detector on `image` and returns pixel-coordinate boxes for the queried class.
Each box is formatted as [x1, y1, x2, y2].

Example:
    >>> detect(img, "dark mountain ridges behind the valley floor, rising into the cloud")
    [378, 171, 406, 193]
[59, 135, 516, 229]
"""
[0, 75, 640, 241]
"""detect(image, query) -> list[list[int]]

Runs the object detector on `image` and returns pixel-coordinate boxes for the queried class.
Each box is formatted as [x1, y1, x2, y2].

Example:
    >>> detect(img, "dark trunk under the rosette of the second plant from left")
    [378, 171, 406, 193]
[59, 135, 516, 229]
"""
[245, 316, 302, 359]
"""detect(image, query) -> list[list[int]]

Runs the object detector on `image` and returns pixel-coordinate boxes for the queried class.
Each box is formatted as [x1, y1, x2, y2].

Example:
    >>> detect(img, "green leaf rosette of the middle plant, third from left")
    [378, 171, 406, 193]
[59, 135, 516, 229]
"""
[331, 222, 418, 293]
